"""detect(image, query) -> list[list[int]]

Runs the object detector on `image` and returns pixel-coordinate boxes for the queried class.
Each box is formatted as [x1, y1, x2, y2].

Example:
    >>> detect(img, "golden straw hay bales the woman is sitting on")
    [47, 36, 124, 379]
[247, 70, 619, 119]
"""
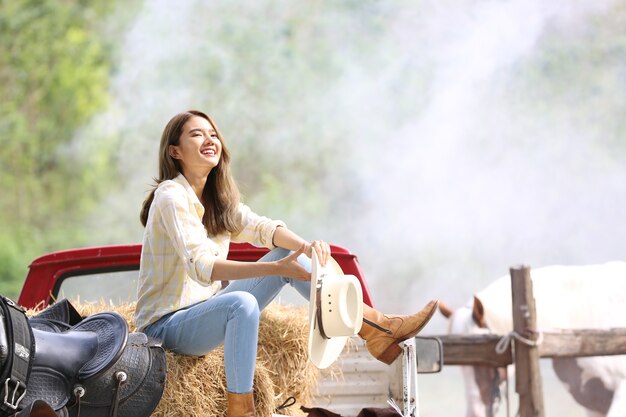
[42, 301, 319, 417]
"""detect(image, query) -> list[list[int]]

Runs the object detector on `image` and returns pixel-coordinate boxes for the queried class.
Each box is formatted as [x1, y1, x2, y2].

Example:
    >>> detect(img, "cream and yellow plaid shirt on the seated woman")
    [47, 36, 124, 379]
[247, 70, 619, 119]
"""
[135, 175, 285, 330]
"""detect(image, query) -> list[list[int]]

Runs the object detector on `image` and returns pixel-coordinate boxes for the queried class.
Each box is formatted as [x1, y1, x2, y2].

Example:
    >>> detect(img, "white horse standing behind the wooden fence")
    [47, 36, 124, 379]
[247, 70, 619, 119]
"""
[439, 261, 626, 417]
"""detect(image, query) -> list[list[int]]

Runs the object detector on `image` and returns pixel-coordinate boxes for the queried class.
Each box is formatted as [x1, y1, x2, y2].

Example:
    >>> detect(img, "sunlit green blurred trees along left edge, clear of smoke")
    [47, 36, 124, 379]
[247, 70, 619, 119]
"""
[0, 0, 137, 296]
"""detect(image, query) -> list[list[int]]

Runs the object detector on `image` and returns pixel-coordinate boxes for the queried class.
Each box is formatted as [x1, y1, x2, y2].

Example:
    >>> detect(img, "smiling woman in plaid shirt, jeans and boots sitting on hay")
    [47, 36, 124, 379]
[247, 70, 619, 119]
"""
[135, 110, 437, 416]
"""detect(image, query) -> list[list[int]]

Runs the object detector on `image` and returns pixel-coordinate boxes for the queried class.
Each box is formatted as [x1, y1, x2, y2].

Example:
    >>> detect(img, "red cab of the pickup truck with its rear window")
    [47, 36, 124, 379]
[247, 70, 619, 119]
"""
[18, 243, 372, 308]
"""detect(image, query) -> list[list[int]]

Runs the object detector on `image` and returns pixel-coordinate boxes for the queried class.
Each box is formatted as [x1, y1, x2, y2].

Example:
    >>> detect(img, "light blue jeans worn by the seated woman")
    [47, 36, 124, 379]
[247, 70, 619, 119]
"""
[140, 248, 311, 394]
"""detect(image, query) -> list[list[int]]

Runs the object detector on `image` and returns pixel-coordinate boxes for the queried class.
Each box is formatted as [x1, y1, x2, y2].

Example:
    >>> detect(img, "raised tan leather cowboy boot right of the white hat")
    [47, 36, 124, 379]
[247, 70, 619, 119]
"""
[359, 300, 439, 365]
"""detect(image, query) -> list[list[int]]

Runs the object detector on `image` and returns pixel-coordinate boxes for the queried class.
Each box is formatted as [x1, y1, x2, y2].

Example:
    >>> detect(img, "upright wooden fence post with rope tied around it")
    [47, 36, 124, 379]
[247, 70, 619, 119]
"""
[510, 266, 544, 417]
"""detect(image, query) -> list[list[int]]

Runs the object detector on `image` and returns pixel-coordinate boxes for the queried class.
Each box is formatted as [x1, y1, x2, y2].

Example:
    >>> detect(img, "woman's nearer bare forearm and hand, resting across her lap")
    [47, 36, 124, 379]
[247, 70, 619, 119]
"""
[211, 245, 311, 281]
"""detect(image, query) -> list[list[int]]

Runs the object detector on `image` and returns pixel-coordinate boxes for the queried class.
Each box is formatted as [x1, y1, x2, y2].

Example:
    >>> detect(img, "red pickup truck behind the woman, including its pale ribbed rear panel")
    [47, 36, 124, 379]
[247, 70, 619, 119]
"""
[18, 243, 441, 416]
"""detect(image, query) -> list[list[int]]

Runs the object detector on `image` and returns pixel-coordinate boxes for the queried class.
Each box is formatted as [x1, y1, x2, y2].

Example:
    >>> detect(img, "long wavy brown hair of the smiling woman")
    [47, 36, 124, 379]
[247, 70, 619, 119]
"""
[139, 110, 240, 236]
